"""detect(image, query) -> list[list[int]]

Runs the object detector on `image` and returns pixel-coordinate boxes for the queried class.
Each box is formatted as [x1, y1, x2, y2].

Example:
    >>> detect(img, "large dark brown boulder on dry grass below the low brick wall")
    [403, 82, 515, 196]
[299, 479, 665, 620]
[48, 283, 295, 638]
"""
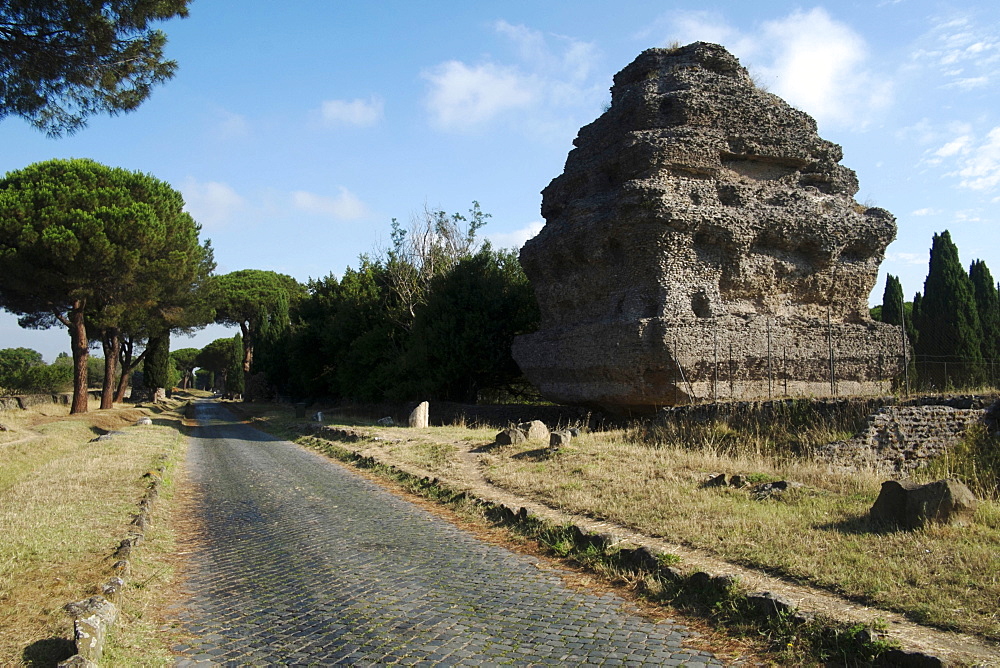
[869, 479, 979, 529]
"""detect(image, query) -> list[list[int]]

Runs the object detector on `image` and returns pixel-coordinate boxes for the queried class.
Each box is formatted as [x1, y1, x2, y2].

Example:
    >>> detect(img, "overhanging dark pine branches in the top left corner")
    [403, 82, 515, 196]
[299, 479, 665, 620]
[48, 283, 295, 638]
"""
[0, 0, 190, 136]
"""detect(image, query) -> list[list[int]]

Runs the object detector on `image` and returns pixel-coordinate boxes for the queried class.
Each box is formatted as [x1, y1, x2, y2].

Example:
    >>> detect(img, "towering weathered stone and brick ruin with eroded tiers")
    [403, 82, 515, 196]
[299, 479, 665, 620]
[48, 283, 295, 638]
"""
[513, 42, 903, 413]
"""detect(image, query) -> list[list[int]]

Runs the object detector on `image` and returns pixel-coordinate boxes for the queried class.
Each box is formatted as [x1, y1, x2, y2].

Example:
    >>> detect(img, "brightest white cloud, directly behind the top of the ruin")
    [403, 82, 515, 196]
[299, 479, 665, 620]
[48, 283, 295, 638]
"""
[665, 8, 893, 127]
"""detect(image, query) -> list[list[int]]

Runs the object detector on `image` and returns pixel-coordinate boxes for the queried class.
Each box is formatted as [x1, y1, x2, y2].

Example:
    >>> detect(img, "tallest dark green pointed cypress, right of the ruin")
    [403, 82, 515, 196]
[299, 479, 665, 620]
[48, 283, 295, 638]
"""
[917, 230, 983, 388]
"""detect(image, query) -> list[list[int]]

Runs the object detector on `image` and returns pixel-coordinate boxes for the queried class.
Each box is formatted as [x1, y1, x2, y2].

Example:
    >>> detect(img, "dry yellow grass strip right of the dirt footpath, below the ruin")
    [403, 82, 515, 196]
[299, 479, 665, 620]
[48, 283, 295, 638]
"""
[484, 433, 1000, 639]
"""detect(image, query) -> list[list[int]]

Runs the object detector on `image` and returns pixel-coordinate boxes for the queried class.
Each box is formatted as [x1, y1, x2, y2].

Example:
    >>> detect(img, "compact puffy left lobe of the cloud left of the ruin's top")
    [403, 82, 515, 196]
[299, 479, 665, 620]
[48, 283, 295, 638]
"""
[423, 60, 539, 129]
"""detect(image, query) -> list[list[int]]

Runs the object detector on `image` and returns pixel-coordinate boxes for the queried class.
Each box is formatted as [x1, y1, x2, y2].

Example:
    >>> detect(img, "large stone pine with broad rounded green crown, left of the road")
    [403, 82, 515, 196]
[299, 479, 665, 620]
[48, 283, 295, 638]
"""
[0, 160, 214, 413]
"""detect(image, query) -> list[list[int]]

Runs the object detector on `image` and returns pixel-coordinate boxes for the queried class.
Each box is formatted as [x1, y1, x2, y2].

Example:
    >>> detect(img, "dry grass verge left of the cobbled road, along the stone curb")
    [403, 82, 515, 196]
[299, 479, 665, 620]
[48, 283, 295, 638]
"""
[0, 405, 183, 666]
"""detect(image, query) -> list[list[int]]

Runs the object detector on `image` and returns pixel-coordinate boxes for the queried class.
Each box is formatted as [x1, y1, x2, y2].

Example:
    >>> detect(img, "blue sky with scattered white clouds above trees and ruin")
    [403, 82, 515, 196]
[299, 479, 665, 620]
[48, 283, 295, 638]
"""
[0, 0, 1000, 360]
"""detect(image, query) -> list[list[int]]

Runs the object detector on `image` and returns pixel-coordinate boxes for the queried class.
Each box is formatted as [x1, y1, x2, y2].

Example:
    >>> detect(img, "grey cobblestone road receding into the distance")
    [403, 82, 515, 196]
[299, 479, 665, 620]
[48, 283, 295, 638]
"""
[168, 403, 723, 666]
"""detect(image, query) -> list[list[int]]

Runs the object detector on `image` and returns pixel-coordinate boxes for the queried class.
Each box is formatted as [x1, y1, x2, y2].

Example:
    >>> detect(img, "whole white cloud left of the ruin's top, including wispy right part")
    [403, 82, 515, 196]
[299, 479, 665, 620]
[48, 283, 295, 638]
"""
[422, 21, 606, 135]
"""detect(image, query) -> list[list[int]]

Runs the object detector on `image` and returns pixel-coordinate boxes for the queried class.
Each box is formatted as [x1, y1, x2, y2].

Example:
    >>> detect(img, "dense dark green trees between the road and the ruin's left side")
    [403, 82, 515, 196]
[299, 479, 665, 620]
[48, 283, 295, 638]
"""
[284, 202, 538, 402]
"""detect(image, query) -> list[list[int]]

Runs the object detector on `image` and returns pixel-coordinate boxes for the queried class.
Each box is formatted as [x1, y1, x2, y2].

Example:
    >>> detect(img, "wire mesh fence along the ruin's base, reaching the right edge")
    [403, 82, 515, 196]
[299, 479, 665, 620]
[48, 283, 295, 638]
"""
[666, 318, 1000, 405]
